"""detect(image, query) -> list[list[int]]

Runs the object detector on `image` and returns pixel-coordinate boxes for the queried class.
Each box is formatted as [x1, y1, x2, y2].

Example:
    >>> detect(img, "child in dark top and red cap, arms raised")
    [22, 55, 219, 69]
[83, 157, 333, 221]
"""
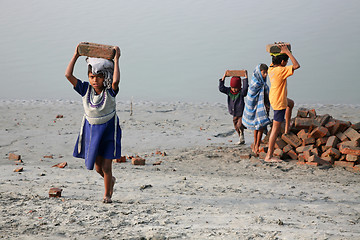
[219, 71, 249, 144]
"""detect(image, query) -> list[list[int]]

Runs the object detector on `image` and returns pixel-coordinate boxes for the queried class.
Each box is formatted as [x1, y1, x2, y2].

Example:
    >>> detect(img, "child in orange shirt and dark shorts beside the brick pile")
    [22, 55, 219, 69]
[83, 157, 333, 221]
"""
[265, 44, 300, 162]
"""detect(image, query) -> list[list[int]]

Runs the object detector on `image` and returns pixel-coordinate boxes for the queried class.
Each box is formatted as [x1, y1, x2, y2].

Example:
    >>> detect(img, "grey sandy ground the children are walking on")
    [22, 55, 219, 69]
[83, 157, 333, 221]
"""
[0, 100, 360, 239]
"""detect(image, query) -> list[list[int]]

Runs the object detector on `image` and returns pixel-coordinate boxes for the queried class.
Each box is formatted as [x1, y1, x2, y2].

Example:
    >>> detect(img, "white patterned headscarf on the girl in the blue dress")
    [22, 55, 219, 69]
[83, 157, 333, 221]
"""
[86, 57, 114, 88]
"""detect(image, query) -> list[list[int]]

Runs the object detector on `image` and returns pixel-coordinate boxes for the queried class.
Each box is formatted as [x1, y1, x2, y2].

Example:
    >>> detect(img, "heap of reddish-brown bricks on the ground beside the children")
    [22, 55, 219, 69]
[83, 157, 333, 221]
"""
[260, 108, 360, 171]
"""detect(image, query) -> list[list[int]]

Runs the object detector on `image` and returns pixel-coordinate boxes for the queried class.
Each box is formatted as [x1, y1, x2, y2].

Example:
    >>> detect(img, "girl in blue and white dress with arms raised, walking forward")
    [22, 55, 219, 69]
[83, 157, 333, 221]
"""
[65, 46, 121, 203]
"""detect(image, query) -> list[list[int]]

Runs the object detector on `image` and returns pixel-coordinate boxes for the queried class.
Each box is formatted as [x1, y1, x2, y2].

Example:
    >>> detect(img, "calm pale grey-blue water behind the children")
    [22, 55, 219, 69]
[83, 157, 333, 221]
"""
[0, 0, 360, 104]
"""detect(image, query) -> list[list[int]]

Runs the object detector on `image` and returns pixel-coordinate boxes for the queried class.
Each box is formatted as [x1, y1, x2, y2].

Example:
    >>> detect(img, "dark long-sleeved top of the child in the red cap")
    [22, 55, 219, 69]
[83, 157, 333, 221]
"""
[219, 78, 249, 117]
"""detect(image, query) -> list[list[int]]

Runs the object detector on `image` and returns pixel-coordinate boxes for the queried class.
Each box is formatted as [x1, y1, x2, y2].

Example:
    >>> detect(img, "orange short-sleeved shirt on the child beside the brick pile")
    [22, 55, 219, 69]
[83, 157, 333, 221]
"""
[268, 64, 294, 110]
